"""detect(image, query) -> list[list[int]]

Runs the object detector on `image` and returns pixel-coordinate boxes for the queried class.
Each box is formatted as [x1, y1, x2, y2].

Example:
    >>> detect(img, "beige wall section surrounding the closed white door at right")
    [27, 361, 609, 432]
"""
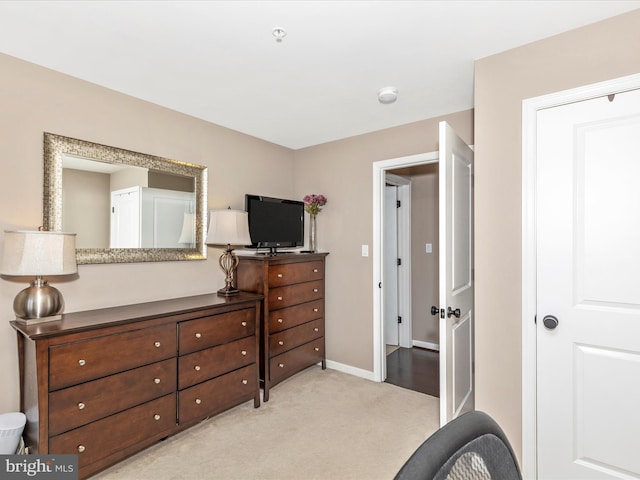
[475, 10, 640, 464]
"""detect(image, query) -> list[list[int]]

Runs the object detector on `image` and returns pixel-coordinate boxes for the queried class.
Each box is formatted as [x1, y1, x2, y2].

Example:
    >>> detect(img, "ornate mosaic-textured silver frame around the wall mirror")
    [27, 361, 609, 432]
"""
[43, 133, 207, 265]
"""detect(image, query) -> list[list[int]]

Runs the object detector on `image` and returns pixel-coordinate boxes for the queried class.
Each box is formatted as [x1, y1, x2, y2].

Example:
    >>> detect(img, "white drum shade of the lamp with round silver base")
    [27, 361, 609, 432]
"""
[0, 230, 78, 276]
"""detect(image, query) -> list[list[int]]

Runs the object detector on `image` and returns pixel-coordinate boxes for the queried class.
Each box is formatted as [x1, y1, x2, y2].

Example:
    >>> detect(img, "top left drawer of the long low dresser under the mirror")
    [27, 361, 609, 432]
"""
[49, 324, 176, 391]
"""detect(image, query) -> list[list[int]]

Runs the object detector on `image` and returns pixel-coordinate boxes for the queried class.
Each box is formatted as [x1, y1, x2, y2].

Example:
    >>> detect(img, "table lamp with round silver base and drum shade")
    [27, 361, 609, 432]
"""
[0, 230, 78, 323]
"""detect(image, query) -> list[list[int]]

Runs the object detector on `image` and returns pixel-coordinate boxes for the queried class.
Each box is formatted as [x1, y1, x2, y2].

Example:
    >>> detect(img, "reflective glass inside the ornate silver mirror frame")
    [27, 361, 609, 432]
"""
[62, 153, 196, 248]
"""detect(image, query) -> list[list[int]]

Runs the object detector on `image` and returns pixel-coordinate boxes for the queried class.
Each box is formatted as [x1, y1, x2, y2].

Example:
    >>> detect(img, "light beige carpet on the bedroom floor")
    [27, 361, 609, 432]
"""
[92, 366, 438, 480]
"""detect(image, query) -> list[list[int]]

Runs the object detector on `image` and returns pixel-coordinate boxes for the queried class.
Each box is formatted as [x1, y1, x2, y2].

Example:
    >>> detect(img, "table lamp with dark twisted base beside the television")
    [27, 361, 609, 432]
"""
[205, 208, 251, 297]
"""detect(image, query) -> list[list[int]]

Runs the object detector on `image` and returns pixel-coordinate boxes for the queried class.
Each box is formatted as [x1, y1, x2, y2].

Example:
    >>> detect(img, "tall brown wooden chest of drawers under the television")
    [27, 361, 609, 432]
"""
[236, 253, 328, 402]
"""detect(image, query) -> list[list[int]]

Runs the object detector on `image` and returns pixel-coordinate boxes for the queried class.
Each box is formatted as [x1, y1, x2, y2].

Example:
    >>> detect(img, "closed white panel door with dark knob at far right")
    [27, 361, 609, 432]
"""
[536, 90, 640, 480]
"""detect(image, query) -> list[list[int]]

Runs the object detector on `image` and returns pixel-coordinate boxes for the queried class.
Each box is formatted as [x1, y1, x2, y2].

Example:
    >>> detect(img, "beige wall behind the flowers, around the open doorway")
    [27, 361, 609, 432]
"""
[294, 111, 473, 371]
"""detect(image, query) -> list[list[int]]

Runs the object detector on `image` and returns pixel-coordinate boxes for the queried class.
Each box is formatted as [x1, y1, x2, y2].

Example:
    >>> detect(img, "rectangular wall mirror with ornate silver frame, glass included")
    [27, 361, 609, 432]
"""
[43, 133, 207, 264]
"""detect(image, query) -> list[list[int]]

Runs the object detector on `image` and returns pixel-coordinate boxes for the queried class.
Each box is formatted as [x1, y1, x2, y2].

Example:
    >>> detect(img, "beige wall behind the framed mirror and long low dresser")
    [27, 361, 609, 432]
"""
[0, 55, 294, 413]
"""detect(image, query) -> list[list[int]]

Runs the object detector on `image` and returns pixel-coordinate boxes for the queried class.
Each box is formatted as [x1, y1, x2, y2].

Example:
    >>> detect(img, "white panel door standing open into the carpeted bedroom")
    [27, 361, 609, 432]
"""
[439, 122, 474, 425]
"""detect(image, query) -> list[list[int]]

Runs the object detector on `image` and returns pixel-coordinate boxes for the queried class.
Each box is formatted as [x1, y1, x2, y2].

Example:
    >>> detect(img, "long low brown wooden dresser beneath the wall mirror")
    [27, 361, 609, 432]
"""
[11, 293, 262, 478]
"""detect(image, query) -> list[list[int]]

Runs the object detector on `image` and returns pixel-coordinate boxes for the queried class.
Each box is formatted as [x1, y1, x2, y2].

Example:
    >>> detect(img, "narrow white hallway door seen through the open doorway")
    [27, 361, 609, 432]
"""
[382, 186, 399, 345]
